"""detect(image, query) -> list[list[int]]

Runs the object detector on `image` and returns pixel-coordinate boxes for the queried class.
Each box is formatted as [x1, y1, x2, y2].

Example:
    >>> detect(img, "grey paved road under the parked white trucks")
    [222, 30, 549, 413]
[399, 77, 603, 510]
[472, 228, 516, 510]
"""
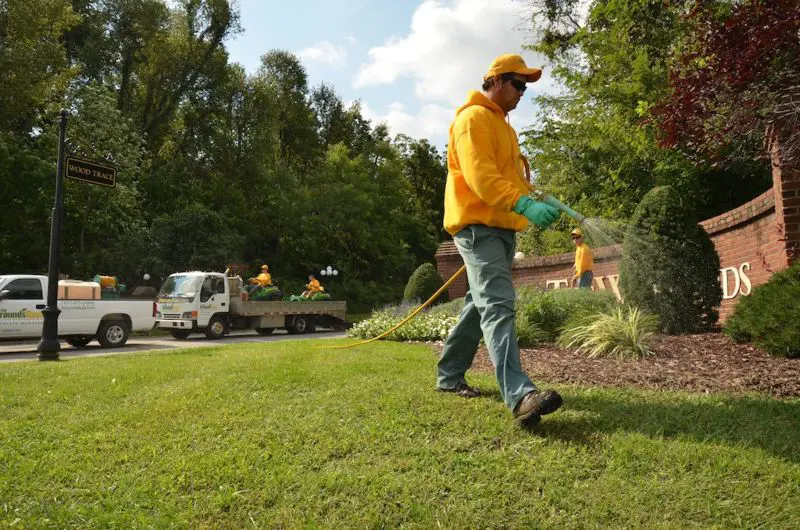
[0, 330, 345, 362]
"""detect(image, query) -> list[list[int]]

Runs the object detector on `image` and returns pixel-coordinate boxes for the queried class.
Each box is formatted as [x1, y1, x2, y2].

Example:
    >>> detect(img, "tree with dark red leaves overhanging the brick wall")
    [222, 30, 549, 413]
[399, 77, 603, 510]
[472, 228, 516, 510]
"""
[651, 0, 800, 163]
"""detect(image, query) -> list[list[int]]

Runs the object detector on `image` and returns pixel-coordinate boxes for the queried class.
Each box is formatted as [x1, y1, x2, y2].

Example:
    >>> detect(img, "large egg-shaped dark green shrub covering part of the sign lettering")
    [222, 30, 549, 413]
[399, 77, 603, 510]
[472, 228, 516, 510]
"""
[620, 186, 722, 333]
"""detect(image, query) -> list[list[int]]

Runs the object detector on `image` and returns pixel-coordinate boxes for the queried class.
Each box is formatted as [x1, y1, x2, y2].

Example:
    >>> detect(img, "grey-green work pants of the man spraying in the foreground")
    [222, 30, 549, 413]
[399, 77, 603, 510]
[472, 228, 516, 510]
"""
[437, 225, 536, 411]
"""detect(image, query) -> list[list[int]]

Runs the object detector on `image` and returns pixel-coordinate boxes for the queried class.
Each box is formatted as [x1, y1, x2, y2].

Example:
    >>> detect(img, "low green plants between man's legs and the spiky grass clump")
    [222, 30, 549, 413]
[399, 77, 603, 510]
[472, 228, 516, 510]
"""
[517, 287, 619, 347]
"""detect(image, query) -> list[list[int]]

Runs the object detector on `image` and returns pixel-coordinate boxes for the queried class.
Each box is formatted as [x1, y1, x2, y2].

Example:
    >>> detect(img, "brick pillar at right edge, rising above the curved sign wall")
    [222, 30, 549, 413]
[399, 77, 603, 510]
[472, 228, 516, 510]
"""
[770, 130, 800, 265]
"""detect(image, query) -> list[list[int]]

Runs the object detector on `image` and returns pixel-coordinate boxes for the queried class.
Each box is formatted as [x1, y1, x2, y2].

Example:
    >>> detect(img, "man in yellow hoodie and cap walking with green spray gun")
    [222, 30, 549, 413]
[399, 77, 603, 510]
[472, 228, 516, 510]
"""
[437, 55, 562, 424]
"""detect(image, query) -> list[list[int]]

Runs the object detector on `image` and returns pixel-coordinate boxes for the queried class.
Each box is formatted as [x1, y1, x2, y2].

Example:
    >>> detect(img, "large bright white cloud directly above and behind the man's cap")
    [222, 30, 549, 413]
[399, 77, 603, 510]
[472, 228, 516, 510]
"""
[354, 0, 555, 104]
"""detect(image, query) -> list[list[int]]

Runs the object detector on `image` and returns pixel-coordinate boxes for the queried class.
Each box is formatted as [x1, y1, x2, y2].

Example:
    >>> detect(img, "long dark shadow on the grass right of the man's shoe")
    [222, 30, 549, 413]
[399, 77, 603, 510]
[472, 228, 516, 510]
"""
[529, 392, 800, 463]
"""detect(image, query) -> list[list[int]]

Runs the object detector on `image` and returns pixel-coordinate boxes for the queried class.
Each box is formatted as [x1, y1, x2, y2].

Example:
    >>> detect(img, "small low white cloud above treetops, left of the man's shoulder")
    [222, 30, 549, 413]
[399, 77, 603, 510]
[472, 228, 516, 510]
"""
[361, 101, 455, 147]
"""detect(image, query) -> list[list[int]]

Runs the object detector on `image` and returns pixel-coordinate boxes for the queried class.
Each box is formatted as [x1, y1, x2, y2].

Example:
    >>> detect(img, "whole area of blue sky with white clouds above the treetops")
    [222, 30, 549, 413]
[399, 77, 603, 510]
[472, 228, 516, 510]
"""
[226, 0, 554, 149]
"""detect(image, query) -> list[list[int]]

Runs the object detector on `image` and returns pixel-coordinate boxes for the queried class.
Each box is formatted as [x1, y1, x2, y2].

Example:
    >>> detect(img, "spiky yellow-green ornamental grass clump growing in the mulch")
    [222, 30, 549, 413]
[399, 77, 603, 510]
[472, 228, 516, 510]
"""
[558, 307, 658, 359]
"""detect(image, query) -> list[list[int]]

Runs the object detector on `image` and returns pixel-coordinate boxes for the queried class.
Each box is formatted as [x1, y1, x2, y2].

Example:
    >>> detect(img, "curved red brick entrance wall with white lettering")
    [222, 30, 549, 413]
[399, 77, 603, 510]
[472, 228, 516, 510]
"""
[436, 137, 800, 321]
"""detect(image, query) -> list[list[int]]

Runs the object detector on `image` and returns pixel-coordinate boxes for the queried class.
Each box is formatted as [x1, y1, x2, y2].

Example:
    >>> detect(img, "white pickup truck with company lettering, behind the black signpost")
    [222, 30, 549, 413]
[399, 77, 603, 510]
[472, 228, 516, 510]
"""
[0, 274, 156, 348]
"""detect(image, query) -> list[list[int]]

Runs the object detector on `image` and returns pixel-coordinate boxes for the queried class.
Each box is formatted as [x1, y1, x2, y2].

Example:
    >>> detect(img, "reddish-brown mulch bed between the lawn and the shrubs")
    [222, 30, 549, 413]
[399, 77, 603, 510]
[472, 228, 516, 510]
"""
[444, 333, 800, 397]
